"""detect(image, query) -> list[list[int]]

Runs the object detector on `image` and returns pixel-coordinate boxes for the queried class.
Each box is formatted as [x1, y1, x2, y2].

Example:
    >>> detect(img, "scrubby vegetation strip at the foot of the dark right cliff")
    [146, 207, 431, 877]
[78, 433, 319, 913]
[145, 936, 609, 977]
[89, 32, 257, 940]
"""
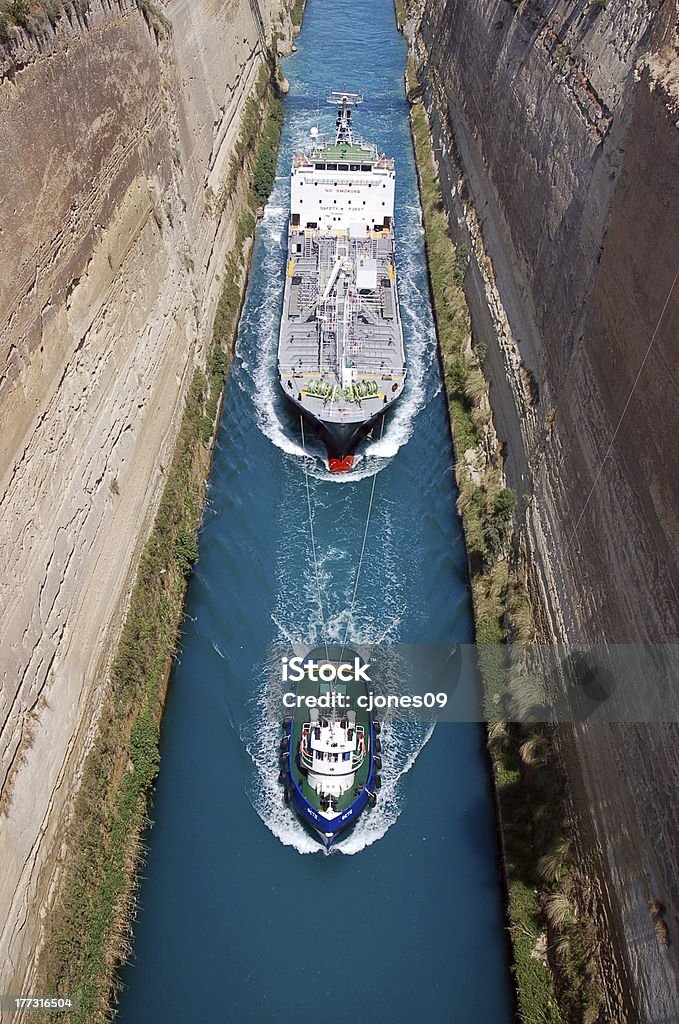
[405, 48, 602, 1024]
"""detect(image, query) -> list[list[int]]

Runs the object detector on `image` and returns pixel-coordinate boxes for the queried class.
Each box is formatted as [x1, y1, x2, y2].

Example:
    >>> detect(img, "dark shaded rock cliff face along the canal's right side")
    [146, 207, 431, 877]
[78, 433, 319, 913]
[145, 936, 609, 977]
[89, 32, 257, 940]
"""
[410, 0, 679, 1021]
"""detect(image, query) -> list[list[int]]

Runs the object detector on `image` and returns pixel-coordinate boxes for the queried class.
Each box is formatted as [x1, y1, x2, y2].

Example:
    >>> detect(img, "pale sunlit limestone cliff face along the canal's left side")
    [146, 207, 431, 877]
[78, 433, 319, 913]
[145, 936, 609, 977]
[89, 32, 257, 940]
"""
[0, 0, 290, 991]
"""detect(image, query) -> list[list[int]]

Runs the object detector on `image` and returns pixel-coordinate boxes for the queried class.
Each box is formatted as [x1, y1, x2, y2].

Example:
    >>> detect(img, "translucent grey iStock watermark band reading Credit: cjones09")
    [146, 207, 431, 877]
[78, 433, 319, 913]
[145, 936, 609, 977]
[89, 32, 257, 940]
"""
[262, 642, 679, 723]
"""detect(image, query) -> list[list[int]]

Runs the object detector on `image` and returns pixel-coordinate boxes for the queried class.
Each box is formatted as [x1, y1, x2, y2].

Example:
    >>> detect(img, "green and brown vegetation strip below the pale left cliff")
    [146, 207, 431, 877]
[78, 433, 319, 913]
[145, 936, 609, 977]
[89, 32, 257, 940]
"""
[34, 56, 283, 1024]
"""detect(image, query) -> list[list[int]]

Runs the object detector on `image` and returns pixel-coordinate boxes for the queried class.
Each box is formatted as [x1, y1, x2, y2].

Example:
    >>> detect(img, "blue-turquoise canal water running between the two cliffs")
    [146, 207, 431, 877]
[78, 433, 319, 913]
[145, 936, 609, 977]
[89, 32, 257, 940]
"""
[115, 0, 512, 1024]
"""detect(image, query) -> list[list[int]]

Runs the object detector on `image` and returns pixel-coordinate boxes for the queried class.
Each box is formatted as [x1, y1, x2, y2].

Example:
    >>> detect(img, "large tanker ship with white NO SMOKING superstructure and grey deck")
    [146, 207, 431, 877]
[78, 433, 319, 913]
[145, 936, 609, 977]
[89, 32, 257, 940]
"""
[278, 92, 406, 472]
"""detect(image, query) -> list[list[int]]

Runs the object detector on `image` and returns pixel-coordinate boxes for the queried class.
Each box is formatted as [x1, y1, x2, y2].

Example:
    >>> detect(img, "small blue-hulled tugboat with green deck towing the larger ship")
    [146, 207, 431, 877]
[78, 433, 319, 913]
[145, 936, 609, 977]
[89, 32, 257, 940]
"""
[279, 647, 382, 849]
